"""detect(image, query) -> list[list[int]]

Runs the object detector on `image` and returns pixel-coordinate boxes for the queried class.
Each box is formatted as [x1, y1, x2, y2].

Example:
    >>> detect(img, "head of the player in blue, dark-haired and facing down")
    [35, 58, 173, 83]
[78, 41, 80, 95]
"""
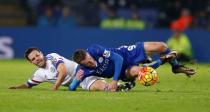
[73, 49, 96, 68]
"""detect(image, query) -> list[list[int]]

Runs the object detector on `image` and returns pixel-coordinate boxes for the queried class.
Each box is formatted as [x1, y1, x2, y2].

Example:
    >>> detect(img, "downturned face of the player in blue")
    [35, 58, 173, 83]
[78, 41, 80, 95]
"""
[80, 53, 97, 68]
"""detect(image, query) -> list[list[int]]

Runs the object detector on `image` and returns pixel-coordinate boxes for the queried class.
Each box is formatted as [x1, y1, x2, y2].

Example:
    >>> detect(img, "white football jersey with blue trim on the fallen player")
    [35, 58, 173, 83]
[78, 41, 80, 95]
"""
[27, 53, 78, 87]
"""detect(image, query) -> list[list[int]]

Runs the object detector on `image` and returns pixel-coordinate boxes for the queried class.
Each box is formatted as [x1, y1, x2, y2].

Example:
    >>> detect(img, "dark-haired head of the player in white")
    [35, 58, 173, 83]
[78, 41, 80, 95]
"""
[25, 47, 46, 67]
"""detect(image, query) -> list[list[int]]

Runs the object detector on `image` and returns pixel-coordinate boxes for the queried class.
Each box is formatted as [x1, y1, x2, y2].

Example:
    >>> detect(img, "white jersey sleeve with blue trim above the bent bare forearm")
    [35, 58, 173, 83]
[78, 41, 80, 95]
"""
[46, 53, 64, 69]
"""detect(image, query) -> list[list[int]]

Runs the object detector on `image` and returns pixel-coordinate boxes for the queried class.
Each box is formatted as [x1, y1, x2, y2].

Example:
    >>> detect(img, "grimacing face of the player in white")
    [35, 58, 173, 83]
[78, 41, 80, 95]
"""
[28, 50, 46, 67]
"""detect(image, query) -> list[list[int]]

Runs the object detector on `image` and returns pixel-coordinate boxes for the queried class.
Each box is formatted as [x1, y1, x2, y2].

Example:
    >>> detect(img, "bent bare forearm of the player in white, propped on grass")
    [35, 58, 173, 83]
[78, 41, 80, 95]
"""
[52, 64, 67, 90]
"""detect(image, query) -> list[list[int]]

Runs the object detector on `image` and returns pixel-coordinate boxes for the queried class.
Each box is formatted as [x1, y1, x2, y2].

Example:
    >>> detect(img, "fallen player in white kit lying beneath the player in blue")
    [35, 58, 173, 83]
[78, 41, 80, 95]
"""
[10, 48, 107, 90]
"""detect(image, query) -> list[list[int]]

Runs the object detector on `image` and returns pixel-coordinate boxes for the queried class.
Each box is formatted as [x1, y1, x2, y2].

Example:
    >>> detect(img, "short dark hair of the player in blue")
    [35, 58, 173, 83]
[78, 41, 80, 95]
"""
[73, 49, 87, 63]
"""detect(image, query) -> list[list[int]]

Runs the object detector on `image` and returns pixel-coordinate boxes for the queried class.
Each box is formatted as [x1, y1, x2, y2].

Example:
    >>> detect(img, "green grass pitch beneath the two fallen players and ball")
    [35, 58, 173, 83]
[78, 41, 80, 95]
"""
[0, 60, 210, 112]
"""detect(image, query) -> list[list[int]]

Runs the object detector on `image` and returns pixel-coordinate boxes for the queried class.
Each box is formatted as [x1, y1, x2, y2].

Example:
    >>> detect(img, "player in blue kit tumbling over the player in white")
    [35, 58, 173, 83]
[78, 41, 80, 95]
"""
[69, 42, 195, 91]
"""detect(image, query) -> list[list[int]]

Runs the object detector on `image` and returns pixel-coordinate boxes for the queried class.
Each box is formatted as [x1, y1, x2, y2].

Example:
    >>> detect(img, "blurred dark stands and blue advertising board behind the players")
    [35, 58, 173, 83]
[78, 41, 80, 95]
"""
[0, 0, 210, 62]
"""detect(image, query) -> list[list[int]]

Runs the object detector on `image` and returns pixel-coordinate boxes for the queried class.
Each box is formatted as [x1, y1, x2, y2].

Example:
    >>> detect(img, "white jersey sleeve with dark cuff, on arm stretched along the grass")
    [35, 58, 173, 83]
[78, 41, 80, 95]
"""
[27, 70, 46, 87]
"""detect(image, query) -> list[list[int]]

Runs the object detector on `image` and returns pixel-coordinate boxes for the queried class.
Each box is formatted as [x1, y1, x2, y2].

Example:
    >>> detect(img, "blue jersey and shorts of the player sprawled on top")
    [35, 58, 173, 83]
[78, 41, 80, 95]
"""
[82, 42, 146, 80]
